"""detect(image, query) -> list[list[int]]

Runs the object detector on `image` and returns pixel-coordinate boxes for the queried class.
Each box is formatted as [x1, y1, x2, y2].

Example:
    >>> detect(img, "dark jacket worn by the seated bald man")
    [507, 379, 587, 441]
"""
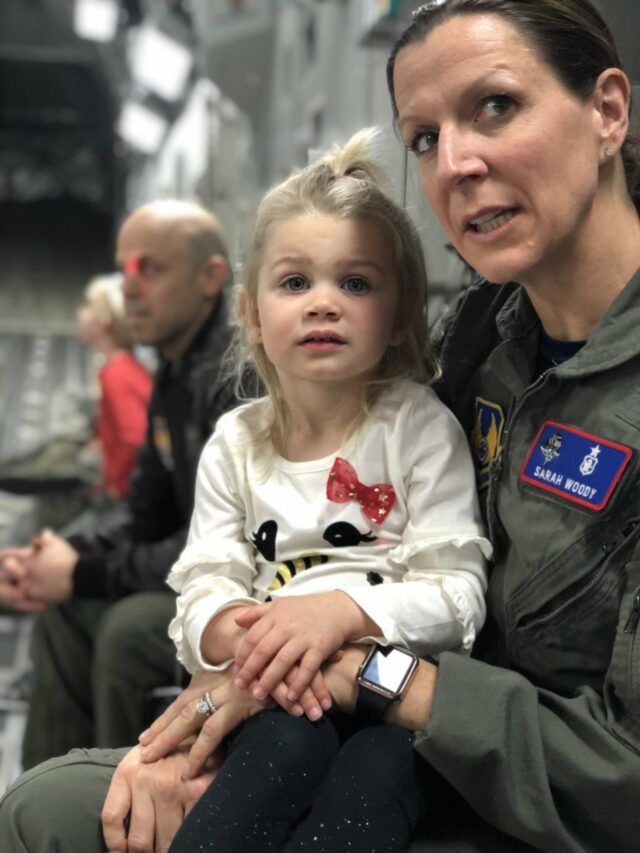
[70, 295, 236, 599]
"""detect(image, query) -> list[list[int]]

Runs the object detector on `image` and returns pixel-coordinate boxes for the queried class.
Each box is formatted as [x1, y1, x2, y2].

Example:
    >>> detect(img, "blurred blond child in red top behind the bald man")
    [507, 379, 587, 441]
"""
[78, 273, 152, 500]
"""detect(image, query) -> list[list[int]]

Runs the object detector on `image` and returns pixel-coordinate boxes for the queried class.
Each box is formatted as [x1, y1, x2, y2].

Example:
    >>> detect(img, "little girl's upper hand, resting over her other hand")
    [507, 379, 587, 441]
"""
[235, 591, 362, 702]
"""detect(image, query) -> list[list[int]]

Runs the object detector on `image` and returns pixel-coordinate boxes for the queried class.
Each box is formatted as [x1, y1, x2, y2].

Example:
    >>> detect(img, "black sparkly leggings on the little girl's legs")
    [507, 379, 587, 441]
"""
[170, 709, 426, 853]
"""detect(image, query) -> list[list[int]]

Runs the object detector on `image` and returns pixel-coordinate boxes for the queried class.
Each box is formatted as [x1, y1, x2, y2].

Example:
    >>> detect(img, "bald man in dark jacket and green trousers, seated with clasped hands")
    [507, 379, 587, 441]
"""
[0, 201, 235, 767]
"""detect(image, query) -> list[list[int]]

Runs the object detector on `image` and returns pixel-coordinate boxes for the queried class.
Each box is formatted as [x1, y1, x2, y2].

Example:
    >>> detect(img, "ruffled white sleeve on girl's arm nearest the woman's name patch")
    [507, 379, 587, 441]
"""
[330, 389, 491, 655]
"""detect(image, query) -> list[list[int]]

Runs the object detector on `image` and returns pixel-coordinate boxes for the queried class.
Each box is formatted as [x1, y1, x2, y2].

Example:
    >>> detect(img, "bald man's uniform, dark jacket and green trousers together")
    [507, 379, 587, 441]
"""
[23, 298, 235, 767]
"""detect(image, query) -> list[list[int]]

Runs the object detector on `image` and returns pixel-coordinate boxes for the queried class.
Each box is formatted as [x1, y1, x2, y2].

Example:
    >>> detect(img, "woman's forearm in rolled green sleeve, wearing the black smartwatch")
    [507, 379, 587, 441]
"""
[323, 647, 640, 853]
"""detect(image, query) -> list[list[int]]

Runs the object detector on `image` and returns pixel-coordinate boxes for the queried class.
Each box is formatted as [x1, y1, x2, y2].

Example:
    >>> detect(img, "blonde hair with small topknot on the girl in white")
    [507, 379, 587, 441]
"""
[234, 130, 437, 449]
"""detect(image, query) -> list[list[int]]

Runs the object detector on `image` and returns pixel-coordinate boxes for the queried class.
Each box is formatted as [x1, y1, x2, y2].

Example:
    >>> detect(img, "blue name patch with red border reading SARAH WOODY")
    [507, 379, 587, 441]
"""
[520, 421, 632, 511]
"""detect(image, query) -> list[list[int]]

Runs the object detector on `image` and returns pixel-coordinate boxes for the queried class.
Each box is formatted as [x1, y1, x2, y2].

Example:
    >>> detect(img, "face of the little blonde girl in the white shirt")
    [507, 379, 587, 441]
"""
[247, 217, 398, 395]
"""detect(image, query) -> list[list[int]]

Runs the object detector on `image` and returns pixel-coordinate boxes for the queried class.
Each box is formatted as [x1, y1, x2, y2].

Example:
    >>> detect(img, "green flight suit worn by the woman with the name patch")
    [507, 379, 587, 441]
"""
[0, 274, 640, 853]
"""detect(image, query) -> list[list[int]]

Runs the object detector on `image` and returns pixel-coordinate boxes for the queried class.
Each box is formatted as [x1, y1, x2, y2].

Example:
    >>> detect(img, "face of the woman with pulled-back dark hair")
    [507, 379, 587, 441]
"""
[394, 14, 601, 284]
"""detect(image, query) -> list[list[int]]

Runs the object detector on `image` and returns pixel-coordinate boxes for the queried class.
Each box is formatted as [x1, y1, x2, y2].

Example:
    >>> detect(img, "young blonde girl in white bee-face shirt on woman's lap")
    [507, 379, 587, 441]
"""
[169, 134, 490, 853]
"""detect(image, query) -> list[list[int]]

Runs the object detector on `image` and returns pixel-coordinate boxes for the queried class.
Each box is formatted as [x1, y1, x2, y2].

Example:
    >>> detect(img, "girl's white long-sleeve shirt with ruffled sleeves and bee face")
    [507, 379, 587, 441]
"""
[168, 381, 491, 672]
